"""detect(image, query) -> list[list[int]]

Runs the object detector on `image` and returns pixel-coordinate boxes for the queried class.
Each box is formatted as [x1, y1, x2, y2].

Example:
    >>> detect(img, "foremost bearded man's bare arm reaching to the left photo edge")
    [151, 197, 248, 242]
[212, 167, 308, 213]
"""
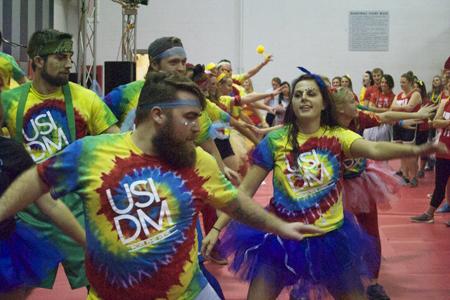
[0, 167, 48, 221]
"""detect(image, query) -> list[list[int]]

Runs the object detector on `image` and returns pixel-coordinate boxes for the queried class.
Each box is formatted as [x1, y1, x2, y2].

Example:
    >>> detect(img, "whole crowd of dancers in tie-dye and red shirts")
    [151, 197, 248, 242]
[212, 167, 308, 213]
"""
[0, 29, 450, 299]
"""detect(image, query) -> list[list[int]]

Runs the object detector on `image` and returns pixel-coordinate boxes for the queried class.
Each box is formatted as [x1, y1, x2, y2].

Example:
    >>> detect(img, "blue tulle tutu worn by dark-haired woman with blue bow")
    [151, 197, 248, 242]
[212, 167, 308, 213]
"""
[221, 213, 380, 298]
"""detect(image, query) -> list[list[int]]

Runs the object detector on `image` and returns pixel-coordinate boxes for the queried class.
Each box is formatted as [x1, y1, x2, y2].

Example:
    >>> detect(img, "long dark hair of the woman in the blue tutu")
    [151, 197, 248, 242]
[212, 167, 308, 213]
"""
[284, 74, 338, 166]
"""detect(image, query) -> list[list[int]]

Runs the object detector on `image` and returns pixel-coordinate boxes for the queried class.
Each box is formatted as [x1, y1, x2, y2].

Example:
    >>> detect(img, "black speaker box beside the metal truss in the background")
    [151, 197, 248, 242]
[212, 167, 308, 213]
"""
[105, 61, 136, 95]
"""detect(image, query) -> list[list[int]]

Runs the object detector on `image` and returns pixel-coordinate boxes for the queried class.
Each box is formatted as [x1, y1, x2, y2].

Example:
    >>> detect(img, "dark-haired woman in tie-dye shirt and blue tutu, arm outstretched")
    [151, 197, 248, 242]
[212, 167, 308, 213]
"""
[207, 75, 446, 299]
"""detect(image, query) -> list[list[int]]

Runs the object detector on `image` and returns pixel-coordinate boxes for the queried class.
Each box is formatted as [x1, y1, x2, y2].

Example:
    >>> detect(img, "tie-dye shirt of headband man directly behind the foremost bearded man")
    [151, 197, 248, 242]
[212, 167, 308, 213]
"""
[103, 80, 216, 145]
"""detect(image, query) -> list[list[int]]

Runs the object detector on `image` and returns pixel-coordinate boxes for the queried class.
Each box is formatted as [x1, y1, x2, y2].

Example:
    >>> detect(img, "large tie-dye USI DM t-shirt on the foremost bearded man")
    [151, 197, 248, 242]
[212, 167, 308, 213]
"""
[38, 132, 237, 299]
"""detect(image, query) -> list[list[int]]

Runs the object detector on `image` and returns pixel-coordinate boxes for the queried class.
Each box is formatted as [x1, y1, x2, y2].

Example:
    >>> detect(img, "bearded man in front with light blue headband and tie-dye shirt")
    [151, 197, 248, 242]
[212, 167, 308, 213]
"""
[0, 72, 322, 300]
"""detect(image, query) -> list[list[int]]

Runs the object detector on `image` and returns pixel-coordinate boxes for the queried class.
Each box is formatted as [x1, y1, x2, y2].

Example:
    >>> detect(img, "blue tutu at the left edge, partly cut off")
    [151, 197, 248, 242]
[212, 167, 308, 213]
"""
[0, 222, 62, 293]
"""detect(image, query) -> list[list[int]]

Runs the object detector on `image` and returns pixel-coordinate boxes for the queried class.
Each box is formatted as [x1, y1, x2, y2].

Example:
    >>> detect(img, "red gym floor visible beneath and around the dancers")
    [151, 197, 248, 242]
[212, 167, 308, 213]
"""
[29, 164, 450, 300]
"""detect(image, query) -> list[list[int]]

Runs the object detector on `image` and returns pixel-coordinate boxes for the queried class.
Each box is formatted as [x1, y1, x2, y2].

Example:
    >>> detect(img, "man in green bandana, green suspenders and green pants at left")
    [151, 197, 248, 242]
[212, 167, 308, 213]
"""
[1, 29, 119, 289]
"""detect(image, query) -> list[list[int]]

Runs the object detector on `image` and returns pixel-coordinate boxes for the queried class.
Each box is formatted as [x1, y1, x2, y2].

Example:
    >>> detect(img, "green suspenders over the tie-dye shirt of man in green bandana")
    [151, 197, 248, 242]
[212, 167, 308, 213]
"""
[15, 82, 76, 143]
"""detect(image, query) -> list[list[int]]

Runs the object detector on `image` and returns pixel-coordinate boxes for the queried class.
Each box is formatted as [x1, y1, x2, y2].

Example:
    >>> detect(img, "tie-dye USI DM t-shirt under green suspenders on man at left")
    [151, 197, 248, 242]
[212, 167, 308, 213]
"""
[1, 82, 117, 162]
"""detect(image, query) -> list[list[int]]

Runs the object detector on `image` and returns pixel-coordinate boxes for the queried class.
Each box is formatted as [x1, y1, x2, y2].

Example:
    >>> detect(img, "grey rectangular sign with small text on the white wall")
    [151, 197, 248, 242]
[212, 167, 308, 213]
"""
[348, 10, 389, 51]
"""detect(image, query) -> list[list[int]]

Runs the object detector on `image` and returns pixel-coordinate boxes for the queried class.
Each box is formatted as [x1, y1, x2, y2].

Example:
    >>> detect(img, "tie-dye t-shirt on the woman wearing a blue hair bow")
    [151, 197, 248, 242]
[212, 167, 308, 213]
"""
[252, 126, 361, 232]
